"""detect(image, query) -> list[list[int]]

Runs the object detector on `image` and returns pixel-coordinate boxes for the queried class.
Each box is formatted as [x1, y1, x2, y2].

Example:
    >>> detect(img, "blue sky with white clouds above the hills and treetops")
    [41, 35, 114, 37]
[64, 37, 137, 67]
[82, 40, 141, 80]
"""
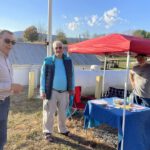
[0, 0, 150, 37]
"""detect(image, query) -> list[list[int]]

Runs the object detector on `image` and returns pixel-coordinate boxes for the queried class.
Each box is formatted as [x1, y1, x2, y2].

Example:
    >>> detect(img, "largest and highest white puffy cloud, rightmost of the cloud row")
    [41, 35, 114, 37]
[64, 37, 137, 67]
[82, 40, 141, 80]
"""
[103, 8, 119, 28]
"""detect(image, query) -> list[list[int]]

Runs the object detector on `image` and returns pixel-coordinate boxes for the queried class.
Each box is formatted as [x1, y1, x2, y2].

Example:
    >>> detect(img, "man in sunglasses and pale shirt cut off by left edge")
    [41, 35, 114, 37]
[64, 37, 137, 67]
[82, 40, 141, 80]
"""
[0, 30, 22, 150]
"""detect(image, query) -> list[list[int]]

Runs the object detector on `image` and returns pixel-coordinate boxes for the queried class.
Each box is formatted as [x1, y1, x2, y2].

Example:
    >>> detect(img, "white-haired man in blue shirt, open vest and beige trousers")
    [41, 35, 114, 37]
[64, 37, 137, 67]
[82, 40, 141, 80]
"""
[40, 41, 74, 142]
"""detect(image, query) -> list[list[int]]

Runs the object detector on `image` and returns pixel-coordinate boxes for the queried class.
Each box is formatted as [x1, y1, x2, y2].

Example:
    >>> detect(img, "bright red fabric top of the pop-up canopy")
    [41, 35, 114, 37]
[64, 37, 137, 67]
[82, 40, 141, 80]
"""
[68, 34, 150, 55]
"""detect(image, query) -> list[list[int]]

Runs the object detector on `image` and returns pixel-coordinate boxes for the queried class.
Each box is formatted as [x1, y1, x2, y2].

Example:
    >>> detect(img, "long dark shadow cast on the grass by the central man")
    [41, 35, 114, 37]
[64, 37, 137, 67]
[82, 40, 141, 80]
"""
[54, 134, 115, 150]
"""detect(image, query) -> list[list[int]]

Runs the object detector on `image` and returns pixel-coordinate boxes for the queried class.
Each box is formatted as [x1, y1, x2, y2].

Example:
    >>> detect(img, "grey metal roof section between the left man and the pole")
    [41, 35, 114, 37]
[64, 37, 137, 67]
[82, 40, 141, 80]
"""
[9, 43, 46, 65]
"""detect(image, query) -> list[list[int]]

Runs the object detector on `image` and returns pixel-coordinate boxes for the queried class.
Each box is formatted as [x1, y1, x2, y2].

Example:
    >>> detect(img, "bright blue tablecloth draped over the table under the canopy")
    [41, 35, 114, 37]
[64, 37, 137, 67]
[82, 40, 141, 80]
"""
[84, 98, 150, 150]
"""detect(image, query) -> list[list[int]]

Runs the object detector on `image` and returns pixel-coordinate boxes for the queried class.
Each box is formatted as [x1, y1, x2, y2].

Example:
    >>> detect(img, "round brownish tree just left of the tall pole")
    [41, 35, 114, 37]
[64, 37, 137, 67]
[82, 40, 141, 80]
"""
[24, 26, 38, 42]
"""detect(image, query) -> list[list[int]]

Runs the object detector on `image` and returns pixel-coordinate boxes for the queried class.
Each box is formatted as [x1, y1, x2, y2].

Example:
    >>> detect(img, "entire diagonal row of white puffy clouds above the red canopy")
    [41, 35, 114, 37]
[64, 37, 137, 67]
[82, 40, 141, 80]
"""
[66, 7, 128, 31]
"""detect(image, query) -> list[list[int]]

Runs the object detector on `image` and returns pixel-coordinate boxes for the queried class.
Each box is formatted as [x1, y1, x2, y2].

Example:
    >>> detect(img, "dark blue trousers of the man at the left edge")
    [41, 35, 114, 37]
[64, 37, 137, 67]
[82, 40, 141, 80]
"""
[0, 97, 10, 150]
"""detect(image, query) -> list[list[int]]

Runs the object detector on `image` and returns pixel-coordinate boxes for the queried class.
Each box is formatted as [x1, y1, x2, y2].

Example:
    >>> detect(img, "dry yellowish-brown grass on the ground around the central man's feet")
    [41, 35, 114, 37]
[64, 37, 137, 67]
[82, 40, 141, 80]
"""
[5, 90, 115, 150]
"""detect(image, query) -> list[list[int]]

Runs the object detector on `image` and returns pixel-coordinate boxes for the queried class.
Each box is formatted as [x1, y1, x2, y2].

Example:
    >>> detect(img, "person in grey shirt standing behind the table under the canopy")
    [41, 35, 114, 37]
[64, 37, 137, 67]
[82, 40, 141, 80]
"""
[129, 54, 150, 107]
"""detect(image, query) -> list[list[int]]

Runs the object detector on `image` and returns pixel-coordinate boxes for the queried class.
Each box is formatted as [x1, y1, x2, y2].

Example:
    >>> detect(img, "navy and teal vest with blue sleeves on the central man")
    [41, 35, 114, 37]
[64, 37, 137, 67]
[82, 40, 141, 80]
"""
[40, 54, 74, 100]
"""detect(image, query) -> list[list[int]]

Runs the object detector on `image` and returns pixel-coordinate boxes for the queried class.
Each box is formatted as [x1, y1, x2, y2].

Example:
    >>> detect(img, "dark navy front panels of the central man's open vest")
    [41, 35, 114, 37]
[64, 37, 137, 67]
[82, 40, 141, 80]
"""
[45, 56, 73, 100]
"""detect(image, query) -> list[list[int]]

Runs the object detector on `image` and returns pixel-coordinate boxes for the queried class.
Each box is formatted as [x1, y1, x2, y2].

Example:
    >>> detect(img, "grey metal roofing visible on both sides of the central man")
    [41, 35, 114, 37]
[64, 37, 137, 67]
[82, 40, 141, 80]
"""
[9, 43, 101, 65]
